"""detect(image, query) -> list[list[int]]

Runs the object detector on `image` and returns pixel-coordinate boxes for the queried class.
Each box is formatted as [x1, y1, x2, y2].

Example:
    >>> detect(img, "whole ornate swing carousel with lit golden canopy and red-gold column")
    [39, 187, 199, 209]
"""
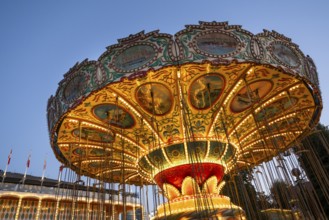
[47, 22, 322, 219]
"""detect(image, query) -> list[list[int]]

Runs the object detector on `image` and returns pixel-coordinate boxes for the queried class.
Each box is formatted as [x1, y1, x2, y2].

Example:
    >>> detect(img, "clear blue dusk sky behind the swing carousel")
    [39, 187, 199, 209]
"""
[0, 0, 329, 178]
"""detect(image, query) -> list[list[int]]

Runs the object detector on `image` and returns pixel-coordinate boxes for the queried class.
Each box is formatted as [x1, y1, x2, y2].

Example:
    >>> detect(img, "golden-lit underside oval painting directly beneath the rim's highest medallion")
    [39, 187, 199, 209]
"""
[189, 74, 224, 109]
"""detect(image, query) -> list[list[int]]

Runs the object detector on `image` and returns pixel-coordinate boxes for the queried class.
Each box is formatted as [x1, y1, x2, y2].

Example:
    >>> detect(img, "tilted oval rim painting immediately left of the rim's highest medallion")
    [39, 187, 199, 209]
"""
[114, 44, 157, 72]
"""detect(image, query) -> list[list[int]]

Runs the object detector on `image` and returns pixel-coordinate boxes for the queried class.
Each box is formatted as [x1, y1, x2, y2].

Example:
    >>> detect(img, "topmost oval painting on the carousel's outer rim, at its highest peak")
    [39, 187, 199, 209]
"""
[196, 32, 239, 56]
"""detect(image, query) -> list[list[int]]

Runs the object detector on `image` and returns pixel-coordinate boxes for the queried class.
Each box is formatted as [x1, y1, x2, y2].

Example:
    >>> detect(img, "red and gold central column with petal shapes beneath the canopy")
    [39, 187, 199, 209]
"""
[153, 162, 245, 220]
